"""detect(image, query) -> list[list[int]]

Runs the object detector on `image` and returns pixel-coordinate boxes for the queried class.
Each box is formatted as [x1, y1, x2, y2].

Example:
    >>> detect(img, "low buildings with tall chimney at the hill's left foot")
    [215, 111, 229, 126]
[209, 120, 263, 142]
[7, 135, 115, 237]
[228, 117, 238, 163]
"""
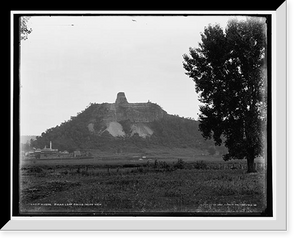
[24, 141, 90, 159]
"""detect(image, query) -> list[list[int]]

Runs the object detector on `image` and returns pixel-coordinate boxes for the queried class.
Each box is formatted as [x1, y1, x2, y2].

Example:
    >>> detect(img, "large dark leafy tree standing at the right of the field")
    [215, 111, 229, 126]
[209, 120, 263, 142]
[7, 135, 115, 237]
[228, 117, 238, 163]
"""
[183, 18, 267, 172]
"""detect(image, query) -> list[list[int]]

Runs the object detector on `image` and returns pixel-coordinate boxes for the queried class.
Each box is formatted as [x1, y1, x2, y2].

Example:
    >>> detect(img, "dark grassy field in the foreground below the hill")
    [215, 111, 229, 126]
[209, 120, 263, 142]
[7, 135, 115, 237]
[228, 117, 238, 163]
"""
[20, 152, 266, 215]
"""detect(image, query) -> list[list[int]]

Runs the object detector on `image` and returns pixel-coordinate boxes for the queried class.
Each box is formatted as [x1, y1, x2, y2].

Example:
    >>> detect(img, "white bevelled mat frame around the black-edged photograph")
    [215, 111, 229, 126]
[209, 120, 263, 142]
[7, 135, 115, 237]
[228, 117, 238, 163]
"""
[5, 5, 287, 231]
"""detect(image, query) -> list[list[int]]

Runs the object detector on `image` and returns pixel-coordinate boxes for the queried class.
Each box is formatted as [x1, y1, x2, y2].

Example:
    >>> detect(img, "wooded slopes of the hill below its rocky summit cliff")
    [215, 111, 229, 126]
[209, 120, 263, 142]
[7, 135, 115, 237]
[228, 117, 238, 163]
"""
[32, 103, 227, 155]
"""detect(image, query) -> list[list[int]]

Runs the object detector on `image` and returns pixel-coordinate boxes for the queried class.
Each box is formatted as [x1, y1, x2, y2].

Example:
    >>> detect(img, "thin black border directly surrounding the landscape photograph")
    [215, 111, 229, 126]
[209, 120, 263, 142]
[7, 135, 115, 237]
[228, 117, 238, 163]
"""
[12, 10, 273, 217]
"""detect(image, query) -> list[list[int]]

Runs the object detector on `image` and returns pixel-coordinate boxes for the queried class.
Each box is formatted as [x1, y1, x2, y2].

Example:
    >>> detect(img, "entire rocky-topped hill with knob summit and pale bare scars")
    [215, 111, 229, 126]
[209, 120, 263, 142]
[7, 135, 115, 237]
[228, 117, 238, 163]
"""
[32, 92, 224, 154]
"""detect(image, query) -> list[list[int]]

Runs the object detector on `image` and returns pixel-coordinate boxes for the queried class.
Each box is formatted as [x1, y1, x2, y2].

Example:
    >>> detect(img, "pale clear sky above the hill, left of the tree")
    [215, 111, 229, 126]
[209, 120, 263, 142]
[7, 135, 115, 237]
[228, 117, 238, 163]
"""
[20, 15, 246, 135]
